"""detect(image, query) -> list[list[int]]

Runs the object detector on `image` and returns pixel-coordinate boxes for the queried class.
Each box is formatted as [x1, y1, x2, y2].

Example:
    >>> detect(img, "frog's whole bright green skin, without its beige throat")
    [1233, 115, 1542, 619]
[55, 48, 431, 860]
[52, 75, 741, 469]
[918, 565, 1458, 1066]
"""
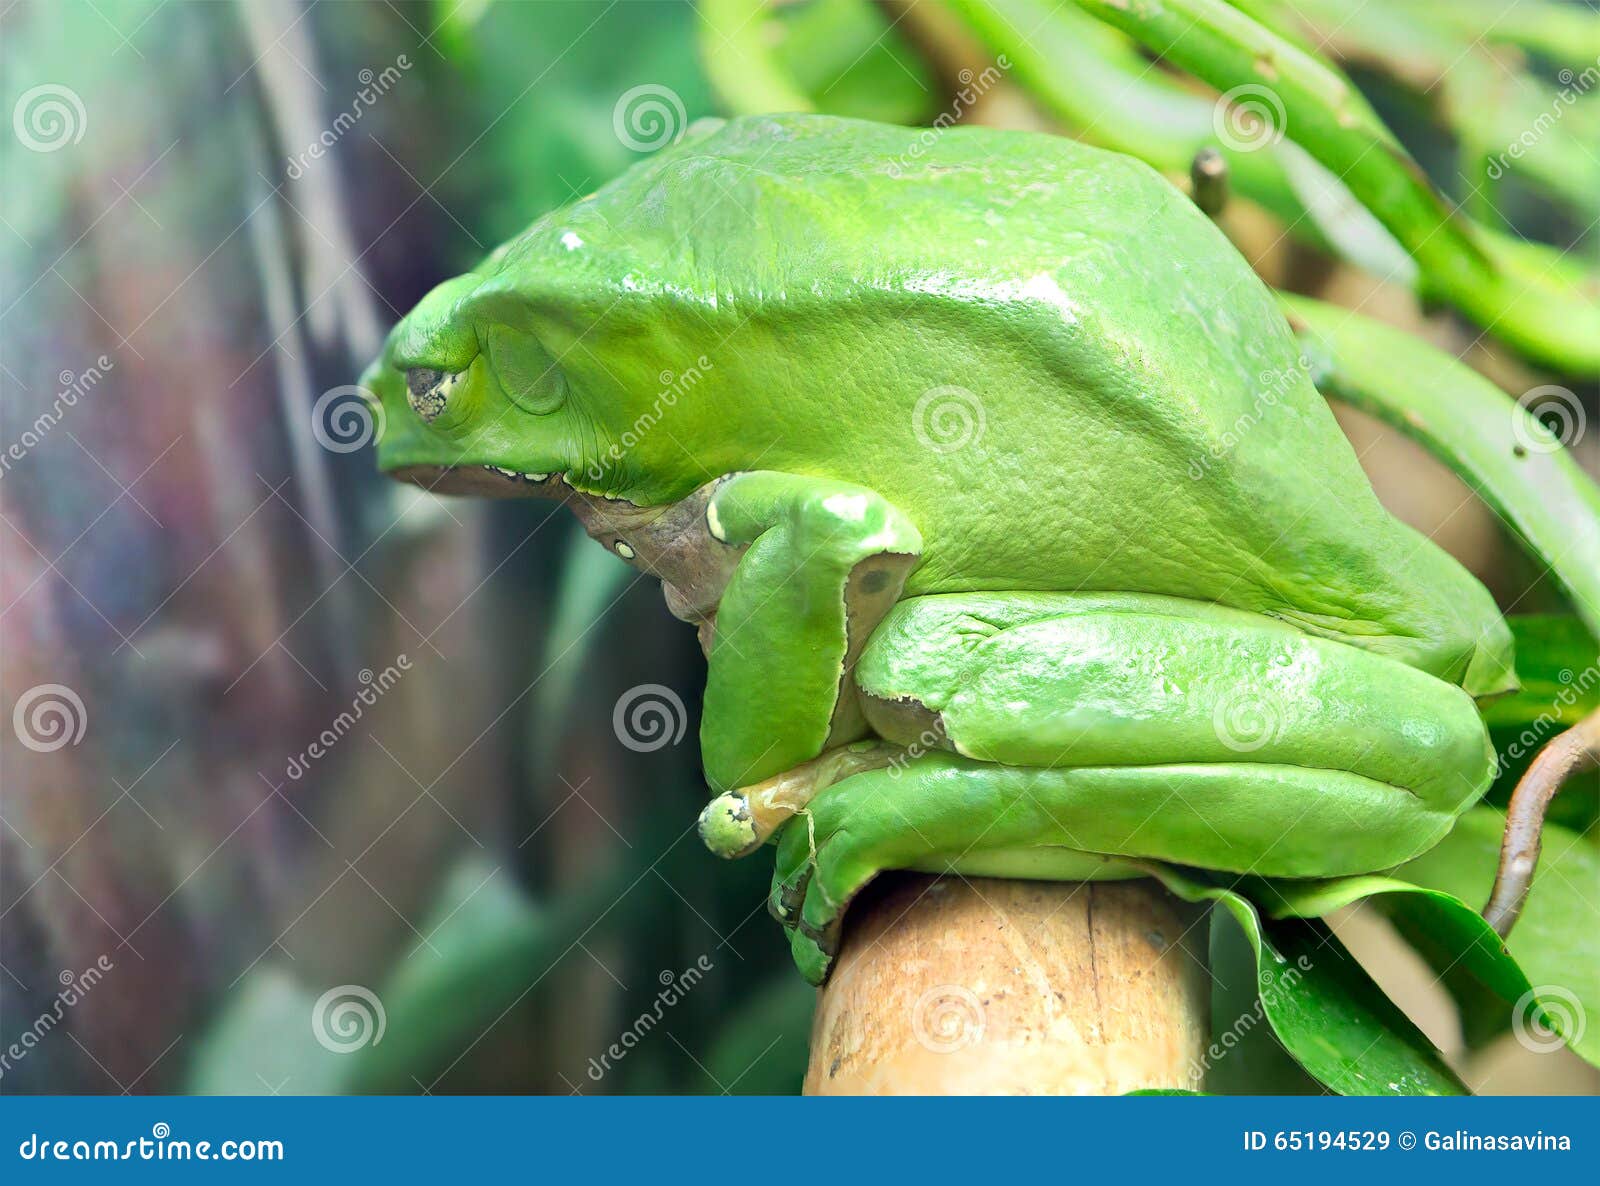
[365, 117, 1514, 978]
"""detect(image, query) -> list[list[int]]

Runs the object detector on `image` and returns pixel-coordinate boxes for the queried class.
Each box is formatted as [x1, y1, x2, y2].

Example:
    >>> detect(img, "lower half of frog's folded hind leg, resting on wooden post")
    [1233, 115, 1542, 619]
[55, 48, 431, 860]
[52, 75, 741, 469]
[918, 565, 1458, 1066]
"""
[768, 752, 1478, 983]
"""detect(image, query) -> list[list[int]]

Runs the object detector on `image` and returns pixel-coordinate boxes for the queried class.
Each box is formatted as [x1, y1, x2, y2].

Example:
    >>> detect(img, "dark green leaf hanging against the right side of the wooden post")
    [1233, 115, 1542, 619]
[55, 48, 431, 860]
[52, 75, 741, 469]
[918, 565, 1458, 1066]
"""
[1152, 866, 1467, 1095]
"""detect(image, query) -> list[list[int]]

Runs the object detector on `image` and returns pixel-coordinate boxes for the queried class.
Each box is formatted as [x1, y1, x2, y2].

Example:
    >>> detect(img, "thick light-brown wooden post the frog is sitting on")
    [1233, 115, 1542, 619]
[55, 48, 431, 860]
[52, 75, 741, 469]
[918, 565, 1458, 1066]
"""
[805, 874, 1210, 1095]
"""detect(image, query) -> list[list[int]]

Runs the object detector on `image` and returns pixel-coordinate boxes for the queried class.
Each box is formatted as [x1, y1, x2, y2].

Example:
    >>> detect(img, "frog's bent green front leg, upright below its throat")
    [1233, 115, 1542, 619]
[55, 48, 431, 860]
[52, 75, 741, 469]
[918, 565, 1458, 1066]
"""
[701, 471, 922, 797]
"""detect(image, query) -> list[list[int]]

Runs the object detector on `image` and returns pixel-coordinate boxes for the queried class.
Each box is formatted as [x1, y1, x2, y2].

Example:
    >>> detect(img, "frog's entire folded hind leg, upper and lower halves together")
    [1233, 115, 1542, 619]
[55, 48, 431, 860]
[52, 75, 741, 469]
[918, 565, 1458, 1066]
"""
[771, 594, 1493, 980]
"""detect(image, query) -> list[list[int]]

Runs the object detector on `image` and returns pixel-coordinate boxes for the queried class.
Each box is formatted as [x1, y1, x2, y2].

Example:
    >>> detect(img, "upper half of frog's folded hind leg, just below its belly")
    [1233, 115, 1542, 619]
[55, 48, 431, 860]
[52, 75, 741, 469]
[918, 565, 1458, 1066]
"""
[856, 594, 1493, 819]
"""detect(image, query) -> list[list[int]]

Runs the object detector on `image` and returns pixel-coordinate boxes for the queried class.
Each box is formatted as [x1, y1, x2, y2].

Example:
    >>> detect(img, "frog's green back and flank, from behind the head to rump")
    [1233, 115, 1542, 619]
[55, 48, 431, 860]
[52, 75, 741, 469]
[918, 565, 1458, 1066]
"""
[499, 115, 1510, 693]
